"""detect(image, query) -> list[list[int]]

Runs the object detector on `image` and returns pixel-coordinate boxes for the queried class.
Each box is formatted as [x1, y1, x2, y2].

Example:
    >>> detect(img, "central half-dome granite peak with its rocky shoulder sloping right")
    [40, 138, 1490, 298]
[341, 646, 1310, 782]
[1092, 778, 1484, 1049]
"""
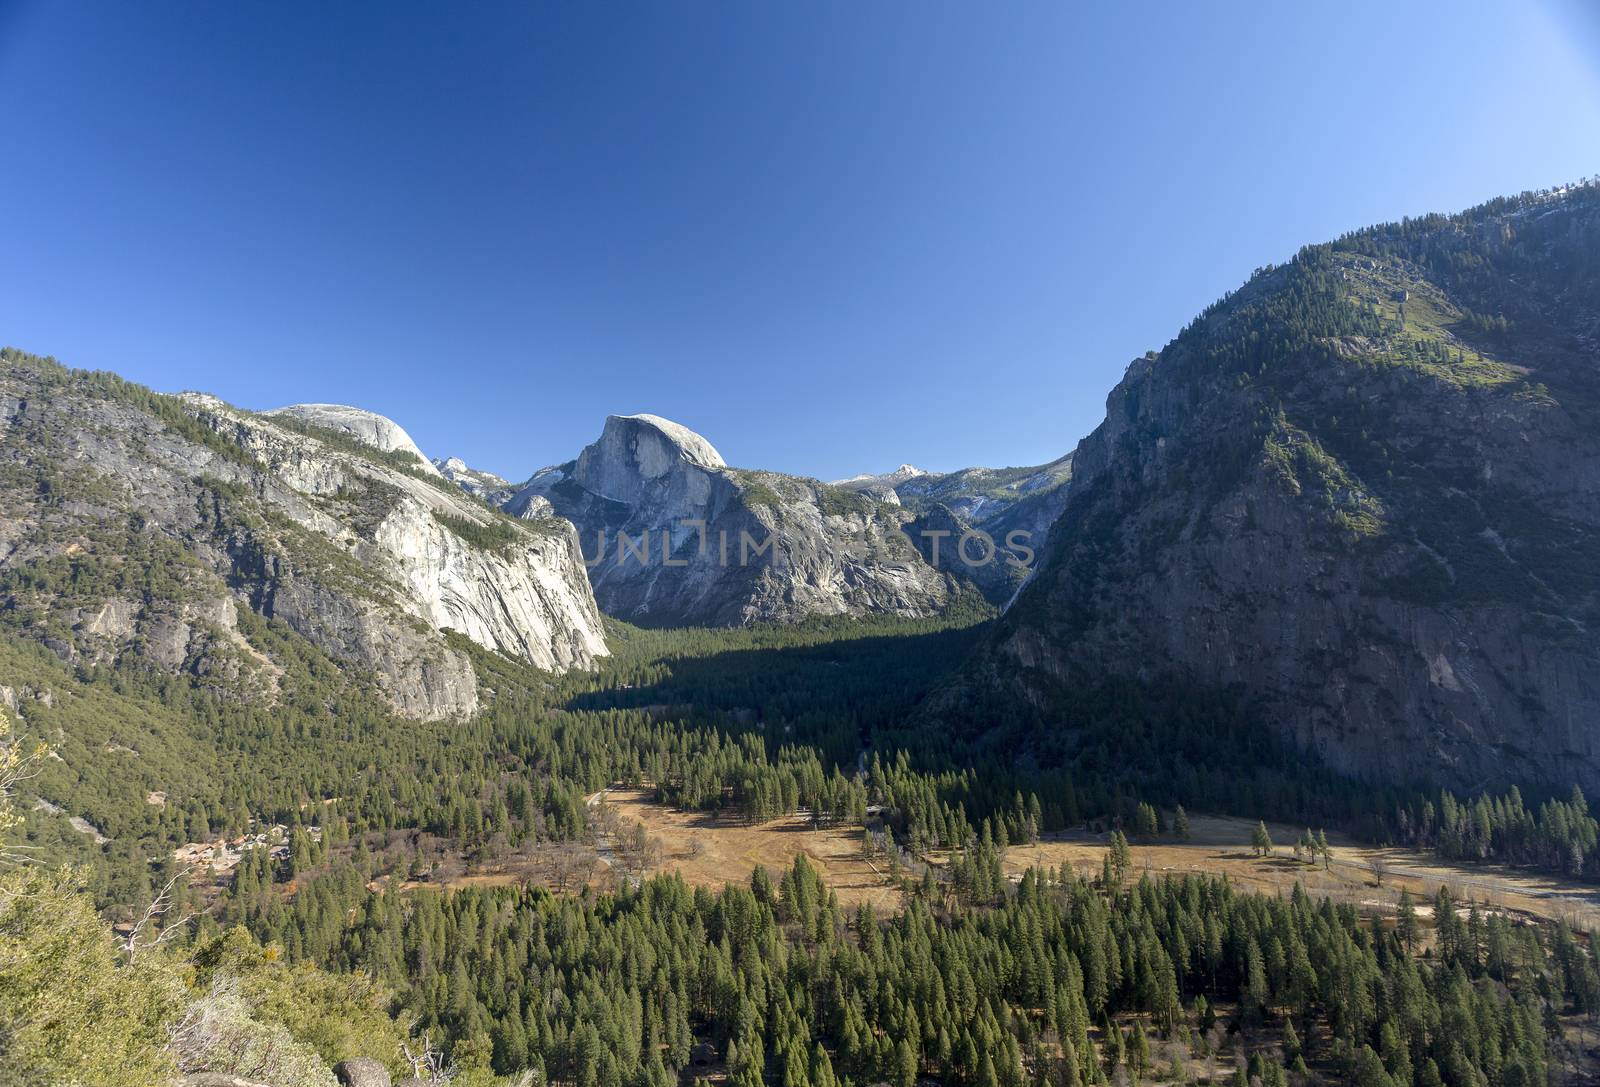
[506, 415, 958, 626]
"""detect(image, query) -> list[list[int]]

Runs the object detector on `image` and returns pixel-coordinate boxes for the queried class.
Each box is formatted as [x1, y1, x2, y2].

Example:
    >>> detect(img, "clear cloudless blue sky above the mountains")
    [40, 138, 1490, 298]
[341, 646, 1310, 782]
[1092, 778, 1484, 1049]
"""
[0, 0, 1600, 479]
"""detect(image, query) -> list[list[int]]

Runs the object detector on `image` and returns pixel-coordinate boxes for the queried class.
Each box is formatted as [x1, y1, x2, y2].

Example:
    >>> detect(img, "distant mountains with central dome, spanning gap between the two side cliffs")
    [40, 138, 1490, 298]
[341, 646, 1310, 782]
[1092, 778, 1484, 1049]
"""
[438, 415, 1070, 626]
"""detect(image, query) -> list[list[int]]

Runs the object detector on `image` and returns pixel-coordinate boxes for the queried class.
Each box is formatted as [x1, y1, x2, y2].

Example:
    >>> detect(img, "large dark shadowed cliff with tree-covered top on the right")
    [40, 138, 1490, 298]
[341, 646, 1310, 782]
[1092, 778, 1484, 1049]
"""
[978, 187, 1600, 791]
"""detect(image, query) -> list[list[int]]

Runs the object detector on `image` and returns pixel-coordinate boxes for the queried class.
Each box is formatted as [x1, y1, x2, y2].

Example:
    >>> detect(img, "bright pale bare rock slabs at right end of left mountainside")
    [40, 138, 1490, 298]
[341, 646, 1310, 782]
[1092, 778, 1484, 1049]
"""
[195, 402, 605, 716]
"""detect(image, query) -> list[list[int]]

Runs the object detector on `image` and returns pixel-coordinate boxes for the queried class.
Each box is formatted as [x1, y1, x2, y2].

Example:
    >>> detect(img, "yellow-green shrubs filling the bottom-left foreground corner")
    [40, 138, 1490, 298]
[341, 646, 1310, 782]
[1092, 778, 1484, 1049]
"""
[0, 869, 408, 1087]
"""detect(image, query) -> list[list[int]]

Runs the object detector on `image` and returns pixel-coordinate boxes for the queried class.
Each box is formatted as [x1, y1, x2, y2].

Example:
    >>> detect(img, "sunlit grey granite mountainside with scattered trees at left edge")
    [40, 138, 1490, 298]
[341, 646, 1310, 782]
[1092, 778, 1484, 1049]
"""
[0, 352, 605, 717]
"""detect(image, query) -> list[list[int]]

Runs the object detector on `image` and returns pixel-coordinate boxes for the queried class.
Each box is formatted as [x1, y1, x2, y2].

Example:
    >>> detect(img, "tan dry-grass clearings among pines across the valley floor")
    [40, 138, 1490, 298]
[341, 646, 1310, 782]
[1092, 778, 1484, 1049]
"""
[179, 786, 1600, 932]
